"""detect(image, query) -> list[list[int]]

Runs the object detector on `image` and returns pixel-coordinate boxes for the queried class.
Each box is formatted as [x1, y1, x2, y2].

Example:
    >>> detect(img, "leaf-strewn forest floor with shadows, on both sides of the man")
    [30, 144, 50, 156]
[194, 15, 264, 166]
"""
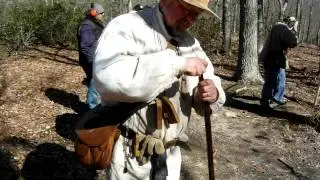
[0, 45, 320, 180]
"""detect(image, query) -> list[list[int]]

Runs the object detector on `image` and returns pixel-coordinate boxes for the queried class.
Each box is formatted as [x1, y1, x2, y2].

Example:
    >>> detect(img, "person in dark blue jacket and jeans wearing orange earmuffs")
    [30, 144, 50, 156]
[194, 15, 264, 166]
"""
[77, 3, 105, 109]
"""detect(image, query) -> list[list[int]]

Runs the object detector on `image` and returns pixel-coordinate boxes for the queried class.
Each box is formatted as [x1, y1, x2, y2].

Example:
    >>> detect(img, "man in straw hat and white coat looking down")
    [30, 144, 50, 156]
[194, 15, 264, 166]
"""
[93, 0, 225, 180]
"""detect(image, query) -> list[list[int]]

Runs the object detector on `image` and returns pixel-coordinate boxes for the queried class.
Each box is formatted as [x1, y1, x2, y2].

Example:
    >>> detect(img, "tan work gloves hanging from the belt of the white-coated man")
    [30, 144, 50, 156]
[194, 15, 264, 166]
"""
[133, 134, 165, 165]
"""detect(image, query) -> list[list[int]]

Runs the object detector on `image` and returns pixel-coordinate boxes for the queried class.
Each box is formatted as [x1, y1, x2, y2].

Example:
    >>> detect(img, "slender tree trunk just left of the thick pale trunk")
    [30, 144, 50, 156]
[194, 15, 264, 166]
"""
[222, 0, 231, 56]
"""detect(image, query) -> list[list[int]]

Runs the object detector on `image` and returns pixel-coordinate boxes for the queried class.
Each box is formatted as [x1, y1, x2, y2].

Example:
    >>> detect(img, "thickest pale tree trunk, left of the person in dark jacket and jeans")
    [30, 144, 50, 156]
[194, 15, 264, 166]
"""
[235, 0, 263, 84]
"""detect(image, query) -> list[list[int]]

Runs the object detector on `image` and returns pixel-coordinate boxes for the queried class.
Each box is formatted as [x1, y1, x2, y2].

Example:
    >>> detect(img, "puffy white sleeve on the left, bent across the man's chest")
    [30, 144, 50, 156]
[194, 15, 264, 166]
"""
[93, 19, 185, 102]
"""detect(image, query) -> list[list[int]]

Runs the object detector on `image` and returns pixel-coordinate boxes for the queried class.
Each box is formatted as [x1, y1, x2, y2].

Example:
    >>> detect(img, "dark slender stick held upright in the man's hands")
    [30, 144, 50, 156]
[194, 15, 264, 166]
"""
[199, 75, 214, 180]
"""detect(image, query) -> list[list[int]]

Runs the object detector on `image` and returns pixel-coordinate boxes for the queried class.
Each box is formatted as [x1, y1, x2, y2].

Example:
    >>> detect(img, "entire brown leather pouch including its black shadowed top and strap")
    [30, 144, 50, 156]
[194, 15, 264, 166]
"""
[74, 103, 146, 169]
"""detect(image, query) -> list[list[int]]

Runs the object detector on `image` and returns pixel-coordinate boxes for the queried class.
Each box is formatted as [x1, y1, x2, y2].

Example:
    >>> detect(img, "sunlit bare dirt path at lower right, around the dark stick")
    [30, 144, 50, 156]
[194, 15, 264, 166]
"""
[183, 97, 320, 180]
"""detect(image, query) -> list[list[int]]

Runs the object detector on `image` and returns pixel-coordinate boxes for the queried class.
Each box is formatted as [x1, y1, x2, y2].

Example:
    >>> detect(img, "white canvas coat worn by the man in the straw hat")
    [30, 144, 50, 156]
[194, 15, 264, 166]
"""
[93, 6, 225, 179]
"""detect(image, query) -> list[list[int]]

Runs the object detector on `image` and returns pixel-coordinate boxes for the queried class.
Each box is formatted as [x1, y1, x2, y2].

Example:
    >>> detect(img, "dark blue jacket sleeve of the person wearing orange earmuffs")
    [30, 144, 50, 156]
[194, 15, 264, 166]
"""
[80, 24, 96, 62]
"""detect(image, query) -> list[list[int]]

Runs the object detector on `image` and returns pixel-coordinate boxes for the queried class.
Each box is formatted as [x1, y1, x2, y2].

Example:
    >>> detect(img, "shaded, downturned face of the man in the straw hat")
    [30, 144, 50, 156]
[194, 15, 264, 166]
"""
[160, 0, 202, 31]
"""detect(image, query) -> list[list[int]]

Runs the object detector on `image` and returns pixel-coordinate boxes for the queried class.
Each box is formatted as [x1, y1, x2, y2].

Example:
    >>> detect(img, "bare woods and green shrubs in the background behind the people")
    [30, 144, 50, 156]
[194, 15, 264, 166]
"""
[0, 0, 320, 51]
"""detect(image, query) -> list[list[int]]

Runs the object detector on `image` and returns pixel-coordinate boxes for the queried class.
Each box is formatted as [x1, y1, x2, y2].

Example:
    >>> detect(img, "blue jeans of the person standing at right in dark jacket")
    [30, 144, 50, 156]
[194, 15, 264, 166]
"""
[261, 67, 286, 102]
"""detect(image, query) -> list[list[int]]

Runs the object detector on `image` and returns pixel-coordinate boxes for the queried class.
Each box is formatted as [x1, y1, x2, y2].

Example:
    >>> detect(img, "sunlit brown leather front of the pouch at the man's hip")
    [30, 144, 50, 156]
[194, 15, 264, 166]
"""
[75, 126, 120, 169]
